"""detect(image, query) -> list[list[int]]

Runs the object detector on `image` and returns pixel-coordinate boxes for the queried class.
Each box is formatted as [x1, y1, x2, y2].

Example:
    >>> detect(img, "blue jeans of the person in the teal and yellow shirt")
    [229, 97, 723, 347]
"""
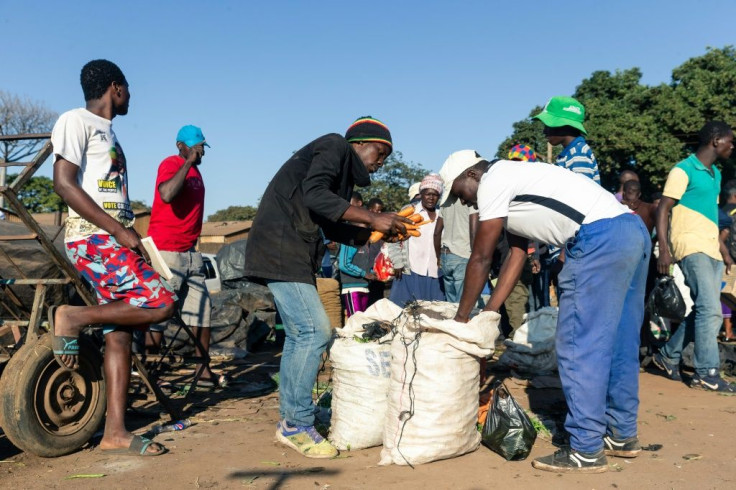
[659, 253, 723, 376]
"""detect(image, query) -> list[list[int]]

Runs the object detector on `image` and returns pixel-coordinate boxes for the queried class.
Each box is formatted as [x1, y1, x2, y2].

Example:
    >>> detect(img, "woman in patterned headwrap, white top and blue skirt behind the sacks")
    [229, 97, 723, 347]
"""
[389, 174, 445, 307]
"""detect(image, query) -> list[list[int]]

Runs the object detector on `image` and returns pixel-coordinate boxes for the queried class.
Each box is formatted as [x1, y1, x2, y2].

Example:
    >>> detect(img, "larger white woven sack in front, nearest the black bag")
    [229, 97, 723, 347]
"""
[379, 301, 500, 465]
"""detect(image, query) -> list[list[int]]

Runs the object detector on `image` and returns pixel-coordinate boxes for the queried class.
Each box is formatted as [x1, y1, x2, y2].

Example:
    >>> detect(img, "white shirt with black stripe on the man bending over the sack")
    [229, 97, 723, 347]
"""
[478, 160, 631, 247]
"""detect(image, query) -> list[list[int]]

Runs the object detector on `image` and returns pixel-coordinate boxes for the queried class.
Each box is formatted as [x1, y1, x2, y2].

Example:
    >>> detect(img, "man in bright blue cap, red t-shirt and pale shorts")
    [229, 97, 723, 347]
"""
[148, 125, 221, 387]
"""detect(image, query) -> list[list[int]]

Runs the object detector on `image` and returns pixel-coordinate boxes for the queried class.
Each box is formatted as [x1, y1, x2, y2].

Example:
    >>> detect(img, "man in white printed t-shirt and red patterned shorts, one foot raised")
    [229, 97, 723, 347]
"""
[49, 60, 176, 456]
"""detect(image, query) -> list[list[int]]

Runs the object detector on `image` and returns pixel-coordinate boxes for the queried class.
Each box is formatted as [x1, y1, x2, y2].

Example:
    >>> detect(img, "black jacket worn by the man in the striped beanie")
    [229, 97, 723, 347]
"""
[245, 134, 371, 284]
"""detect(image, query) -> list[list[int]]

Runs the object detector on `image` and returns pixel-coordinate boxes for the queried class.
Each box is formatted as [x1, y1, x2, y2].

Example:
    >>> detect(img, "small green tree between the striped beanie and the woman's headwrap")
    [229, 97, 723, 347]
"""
[356, 151, 428, 211]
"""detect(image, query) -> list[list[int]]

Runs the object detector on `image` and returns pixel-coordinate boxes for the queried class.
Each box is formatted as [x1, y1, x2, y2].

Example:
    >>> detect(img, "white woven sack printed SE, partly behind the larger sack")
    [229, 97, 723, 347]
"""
[328, 299, 401, 450]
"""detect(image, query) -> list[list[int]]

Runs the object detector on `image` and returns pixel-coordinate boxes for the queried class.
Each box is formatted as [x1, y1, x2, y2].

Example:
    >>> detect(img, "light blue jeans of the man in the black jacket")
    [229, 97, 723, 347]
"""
[267, 281, 332, 426]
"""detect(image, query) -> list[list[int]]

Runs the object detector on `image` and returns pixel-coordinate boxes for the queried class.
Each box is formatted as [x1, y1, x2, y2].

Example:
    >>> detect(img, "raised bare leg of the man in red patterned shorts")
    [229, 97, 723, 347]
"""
[54, 301, 176, 372]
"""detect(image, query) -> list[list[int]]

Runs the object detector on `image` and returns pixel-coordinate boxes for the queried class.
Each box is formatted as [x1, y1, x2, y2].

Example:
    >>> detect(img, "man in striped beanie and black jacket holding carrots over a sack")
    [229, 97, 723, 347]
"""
[245, 116, 410, 458]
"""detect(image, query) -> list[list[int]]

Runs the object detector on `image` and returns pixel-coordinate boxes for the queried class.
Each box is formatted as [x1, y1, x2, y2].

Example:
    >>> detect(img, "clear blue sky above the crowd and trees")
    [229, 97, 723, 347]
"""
[0, 0, 736, 214]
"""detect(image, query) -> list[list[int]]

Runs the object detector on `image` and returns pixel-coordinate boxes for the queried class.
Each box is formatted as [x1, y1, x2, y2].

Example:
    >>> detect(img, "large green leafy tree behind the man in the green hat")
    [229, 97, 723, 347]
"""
[498, 46, 736, 196]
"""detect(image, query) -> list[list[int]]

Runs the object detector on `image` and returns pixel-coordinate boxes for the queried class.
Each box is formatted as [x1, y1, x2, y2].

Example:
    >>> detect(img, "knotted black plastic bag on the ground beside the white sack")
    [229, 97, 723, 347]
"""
[482, 381, 537, 461]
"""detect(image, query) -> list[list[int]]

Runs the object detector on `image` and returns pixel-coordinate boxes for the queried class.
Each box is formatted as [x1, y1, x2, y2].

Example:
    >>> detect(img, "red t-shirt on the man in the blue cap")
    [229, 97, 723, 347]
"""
[148, 155, 204, 252]
